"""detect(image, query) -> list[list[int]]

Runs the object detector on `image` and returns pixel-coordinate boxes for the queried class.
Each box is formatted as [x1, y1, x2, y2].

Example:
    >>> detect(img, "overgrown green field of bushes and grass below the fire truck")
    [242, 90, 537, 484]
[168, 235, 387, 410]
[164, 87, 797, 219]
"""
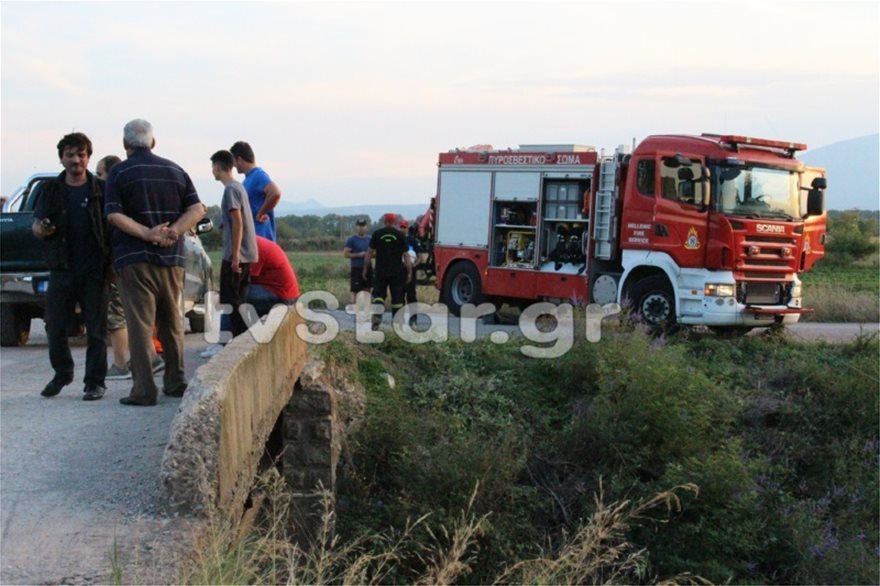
[178, 328, 880, 584]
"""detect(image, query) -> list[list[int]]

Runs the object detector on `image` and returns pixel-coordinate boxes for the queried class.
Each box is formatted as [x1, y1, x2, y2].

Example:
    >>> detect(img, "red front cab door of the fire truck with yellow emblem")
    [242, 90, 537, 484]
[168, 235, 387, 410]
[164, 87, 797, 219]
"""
[653, 153, 709, 267]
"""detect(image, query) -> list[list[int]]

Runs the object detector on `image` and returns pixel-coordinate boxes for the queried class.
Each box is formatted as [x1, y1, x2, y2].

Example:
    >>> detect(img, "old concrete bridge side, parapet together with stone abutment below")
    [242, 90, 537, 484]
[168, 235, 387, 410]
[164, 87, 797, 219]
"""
[160, 311, 342, 538]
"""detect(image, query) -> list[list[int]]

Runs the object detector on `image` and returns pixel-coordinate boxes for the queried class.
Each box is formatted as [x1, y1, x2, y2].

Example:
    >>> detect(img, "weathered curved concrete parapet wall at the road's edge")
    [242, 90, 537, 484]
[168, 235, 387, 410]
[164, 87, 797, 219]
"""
[160, 311, 308, 518]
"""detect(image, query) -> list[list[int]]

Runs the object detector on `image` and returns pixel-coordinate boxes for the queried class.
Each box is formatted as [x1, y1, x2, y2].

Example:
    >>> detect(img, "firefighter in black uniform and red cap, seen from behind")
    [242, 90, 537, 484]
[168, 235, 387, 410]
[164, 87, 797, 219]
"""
[364, 214, 412, 328]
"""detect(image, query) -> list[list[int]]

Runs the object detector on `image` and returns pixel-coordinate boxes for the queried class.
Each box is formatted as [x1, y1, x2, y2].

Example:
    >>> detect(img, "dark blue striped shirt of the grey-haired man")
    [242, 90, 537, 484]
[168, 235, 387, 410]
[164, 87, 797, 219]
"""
[104, 149, 200, 270]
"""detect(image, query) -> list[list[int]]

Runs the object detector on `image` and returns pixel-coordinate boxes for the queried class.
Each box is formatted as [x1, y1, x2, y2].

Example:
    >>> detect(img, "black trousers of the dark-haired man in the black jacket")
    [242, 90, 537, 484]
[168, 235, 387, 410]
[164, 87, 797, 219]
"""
[45, 271, 107, 387]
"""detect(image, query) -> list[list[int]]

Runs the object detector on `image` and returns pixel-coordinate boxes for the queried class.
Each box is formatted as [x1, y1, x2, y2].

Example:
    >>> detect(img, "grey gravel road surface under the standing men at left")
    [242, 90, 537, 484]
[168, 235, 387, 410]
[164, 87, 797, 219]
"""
[0, 320, 207, 584]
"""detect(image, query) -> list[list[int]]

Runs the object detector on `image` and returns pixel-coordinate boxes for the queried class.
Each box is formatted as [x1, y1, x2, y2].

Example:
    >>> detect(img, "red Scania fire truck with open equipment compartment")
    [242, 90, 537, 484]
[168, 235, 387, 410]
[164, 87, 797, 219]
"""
[433, 134, 826, 331]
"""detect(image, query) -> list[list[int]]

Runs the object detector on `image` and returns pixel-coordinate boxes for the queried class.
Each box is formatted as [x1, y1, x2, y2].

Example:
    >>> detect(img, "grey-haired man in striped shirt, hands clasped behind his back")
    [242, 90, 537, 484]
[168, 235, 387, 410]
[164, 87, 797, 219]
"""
[104, 119, 206, 406]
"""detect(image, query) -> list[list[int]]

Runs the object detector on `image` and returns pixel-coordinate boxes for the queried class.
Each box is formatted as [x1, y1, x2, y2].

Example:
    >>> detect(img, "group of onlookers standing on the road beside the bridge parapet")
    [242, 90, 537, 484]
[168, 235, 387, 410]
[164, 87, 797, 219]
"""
[33, 119, 299, 406]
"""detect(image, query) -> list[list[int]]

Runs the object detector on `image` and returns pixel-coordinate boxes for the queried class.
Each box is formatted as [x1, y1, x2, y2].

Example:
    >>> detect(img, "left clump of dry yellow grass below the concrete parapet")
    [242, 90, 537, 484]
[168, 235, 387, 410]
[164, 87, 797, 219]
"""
[177, 471, 483, 585]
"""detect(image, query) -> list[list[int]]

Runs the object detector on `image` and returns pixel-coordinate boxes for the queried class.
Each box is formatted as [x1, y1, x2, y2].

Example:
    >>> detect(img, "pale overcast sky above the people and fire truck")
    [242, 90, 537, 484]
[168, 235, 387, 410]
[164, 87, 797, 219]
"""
[0, 1, 880, 206]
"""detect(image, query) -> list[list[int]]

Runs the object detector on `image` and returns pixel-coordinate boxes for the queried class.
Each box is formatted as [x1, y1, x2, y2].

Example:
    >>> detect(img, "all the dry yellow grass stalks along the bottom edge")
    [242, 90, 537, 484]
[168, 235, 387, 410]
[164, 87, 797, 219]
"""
[177, 471, 706, 585]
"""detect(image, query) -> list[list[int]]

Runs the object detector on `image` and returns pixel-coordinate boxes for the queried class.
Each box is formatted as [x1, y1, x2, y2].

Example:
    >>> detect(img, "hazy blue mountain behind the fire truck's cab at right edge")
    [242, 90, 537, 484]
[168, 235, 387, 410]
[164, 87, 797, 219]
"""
[798, 134, 880, 210]
